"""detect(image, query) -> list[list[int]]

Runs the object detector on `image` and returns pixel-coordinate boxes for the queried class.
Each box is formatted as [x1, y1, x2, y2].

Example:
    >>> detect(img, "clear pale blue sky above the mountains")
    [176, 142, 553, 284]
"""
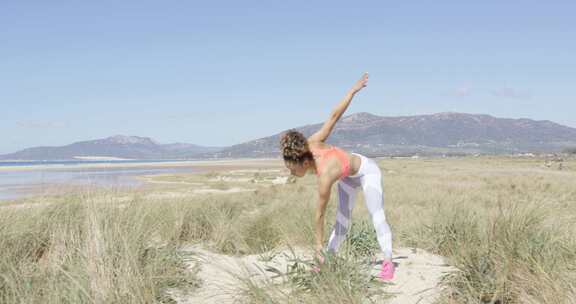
[0, 0, 576, 154]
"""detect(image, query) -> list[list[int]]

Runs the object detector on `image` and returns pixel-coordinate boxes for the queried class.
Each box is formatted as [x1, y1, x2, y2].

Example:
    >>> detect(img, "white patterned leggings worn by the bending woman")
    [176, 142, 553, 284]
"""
[328, 153, 392, 258]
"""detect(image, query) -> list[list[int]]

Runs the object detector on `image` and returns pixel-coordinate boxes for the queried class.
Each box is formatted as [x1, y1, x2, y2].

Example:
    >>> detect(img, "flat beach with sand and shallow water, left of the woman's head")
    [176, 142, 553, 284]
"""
[0, 159, 282, 201]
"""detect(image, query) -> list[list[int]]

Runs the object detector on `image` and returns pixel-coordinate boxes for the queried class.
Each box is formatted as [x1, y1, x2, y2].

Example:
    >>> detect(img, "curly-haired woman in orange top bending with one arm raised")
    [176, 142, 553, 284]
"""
[280, 73, 394, 280]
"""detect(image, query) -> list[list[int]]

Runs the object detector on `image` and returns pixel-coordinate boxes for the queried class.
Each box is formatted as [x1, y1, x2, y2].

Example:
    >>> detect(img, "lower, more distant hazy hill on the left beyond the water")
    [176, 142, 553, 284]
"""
[0, 135, 221, 160]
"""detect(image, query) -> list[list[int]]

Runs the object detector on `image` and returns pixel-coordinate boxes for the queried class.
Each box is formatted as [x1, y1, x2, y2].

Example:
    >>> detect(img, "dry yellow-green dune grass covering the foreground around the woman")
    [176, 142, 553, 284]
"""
[0, 157, 576, 304]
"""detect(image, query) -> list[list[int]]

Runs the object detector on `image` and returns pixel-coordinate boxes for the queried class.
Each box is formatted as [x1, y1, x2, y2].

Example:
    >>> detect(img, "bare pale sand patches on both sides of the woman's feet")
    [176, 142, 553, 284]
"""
[172, 246, 454, 304]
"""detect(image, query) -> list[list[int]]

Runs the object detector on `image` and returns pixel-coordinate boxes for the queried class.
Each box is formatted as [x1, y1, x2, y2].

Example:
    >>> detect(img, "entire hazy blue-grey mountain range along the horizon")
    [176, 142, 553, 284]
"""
[0, 112, 576, 160]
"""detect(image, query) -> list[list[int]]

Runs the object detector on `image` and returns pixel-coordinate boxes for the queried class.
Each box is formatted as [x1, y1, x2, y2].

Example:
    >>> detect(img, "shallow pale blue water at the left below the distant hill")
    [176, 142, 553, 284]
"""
[0, 161, 199, 200]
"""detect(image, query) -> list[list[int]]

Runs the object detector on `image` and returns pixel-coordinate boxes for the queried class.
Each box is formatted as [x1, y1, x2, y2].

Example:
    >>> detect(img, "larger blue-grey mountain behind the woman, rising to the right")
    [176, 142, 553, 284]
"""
[211, 112, 576, 157]
